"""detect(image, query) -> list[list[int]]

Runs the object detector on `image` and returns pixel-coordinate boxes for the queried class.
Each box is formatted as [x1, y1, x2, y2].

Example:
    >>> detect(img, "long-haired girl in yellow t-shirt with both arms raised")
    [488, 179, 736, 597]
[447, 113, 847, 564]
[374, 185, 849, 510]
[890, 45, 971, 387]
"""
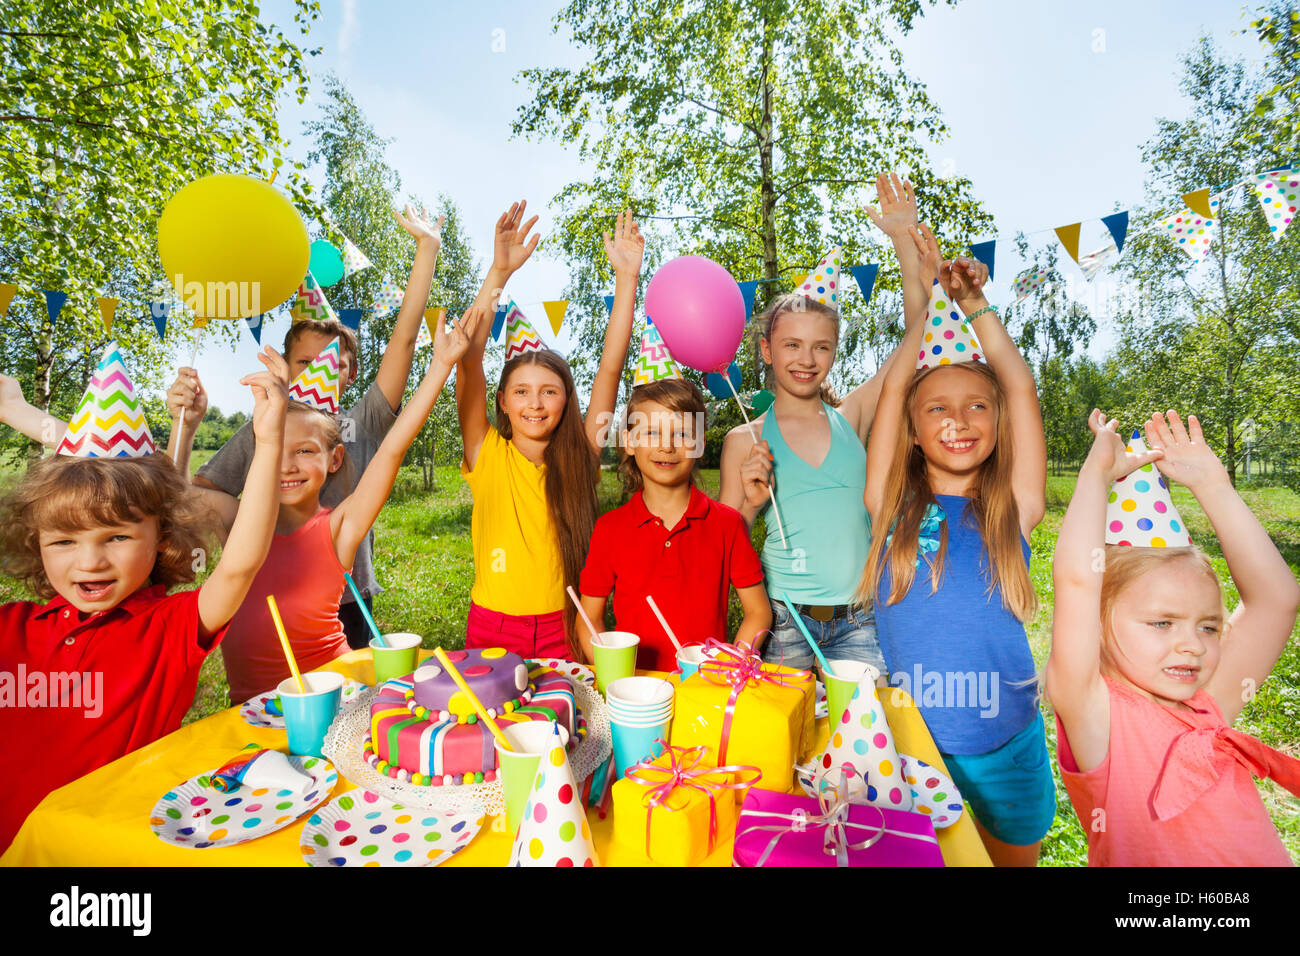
[456, 203, 645, 659]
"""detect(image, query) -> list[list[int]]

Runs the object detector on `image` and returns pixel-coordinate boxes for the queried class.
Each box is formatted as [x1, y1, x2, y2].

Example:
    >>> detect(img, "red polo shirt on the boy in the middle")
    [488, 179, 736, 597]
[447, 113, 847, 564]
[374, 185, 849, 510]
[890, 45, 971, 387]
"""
[581, 488, 763, 671]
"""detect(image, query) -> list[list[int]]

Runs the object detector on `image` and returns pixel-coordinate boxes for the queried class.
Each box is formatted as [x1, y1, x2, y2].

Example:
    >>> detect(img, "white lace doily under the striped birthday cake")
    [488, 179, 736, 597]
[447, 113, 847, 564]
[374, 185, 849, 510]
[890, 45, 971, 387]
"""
[324, 678, 612, 814]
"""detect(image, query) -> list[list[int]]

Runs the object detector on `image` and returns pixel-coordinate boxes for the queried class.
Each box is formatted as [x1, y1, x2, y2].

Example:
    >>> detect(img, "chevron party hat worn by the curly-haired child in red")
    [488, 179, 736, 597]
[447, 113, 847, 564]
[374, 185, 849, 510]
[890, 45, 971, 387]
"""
[57, 342, 157, 458]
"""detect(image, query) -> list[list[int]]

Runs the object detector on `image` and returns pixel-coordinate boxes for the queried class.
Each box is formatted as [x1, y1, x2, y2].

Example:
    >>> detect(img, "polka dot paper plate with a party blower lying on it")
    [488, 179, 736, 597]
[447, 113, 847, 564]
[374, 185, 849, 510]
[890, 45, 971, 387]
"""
[150, 756, 338, 849]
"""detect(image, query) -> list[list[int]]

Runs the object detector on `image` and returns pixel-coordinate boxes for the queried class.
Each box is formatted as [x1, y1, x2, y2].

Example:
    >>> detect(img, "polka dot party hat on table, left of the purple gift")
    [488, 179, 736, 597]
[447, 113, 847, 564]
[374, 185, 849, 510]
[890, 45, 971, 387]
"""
[510, 723, 601, 866]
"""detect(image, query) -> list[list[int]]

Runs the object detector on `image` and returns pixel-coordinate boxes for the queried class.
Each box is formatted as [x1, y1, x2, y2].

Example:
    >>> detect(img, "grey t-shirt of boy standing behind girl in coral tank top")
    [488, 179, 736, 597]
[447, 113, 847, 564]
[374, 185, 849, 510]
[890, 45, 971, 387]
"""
[199, 385, 398, 604]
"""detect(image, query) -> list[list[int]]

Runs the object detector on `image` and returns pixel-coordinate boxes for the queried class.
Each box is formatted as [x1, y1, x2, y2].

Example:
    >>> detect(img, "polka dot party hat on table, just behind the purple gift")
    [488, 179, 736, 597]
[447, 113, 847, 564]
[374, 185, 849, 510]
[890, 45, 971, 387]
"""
[818, 667, 913, 810]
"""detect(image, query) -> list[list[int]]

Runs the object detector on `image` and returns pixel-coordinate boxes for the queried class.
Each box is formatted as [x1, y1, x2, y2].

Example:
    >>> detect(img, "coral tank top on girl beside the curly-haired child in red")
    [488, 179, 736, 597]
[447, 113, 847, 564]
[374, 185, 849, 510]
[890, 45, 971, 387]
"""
[221, 509, 348, 705]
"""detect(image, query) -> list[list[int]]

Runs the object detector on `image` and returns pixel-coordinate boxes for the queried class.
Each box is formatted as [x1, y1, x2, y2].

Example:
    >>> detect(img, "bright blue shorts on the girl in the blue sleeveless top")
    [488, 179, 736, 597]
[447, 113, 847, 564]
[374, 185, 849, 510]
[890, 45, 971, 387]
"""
[944, 711, 1056, 847]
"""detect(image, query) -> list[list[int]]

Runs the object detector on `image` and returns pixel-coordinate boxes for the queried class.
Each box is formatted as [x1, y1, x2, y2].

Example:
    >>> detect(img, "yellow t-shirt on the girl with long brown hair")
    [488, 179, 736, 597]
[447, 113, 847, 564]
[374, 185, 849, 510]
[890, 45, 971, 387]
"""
[460, 428, 564, 614]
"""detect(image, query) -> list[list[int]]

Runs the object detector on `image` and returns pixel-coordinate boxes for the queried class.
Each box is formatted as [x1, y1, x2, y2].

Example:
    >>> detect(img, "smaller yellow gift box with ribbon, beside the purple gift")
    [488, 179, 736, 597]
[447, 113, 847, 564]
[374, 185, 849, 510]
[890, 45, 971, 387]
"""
[612, 741, 762, 866]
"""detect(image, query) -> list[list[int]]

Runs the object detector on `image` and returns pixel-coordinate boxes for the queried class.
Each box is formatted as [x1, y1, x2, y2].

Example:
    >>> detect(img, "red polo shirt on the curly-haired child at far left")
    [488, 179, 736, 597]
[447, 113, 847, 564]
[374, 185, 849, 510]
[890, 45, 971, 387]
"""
[0, 585, 225, 851]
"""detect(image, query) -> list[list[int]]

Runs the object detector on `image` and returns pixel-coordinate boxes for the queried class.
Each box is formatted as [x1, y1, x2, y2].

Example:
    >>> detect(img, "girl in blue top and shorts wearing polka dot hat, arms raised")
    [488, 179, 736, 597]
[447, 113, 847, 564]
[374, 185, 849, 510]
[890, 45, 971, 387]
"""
[858, 228, 1056, 866]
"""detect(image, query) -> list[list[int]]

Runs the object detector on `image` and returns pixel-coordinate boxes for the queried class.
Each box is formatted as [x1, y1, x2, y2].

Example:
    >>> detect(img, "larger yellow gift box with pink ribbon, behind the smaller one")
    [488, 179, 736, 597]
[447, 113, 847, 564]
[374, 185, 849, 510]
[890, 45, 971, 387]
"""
[671, 640, 816, 793]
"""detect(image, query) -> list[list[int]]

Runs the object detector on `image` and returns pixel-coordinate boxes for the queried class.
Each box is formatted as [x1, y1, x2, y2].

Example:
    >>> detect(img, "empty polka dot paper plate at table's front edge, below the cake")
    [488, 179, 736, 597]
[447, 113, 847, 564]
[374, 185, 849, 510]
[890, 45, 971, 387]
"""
[299, 790, 486, 866]
